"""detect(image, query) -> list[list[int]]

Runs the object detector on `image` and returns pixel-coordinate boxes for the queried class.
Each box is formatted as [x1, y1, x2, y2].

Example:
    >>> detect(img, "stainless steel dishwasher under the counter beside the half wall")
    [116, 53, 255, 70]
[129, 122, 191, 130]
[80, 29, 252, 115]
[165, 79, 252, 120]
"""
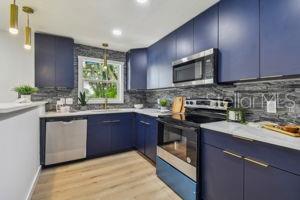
[45, 118, 87, 165]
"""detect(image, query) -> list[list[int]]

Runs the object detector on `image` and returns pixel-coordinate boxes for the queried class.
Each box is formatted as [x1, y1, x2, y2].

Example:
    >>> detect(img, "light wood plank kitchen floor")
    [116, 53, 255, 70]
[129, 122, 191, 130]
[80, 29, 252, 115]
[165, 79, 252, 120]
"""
[32, 151, 180, 200]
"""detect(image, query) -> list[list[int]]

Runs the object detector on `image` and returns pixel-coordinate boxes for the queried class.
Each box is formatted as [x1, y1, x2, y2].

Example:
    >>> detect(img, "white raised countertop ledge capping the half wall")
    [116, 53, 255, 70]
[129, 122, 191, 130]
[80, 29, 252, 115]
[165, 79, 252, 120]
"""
[0, 102, 47, 115]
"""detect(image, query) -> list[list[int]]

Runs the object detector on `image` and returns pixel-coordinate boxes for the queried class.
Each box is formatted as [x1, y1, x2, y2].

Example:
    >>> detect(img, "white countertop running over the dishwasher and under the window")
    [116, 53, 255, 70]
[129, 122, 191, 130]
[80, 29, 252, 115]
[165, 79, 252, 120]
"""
[40, 108, 170, 118]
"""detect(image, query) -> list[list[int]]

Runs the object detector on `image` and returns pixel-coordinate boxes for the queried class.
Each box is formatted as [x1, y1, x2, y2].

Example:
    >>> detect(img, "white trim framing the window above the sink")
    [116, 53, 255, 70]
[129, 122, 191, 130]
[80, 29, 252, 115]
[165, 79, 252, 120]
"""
[78, 56, 125, 104]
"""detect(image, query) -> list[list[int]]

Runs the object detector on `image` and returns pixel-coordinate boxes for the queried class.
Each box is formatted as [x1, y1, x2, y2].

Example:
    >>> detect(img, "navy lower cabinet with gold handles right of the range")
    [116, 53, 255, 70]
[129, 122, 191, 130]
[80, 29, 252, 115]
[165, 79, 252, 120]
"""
[199, 129, 300, 200]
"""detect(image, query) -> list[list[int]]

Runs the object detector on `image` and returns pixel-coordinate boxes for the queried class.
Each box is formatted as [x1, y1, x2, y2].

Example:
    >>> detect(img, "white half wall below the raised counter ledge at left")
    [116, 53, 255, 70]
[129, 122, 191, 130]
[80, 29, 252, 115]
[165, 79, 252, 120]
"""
[0, 106, 44, 200]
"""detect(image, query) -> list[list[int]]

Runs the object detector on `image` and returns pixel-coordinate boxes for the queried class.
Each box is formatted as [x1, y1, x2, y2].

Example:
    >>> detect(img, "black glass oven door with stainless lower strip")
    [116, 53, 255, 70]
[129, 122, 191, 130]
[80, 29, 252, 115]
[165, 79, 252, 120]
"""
[157, 120, 199, 181]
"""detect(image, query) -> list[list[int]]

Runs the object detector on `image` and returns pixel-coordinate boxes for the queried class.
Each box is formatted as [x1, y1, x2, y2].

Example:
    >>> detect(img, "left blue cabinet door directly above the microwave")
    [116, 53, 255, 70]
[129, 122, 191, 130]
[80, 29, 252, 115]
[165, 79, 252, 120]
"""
[176, 20, 194, 59]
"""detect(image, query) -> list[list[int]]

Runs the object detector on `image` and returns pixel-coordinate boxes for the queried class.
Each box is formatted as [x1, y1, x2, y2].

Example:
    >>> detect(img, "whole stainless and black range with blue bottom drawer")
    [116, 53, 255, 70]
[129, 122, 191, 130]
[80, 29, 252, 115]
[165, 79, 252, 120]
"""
[157, 99, 230, 199]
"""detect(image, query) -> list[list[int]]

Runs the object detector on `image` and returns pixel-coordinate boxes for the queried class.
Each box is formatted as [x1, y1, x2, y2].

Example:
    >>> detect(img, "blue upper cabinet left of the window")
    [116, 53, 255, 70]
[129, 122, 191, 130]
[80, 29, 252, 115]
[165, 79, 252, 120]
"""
[35, 33, 74, 88]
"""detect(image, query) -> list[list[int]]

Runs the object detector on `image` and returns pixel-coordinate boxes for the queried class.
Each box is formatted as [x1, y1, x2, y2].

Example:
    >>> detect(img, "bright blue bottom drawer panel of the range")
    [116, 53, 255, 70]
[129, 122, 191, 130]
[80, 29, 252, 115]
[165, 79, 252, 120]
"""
[156, 157, 197, 200]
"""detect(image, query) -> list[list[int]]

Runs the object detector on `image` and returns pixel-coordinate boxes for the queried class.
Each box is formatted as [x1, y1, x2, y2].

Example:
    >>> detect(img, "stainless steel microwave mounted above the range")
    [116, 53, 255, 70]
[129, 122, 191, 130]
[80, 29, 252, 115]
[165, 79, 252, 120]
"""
[172, 49, 218, 86]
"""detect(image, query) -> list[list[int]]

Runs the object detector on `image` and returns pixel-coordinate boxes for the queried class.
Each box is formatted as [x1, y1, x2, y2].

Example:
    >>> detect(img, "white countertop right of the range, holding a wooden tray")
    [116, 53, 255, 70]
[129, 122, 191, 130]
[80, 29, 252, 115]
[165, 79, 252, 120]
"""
[201, 121, 300, 151]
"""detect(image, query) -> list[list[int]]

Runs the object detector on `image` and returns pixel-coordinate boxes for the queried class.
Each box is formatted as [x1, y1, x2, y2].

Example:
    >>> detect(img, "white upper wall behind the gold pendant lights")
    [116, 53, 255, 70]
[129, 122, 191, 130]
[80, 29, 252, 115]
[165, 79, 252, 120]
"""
[0, 30, 34, 102]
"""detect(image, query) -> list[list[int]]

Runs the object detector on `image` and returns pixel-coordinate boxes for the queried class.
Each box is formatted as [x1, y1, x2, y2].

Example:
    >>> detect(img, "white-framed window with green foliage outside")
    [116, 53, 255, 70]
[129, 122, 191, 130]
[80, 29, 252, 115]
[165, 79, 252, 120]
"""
[78, 56, 124, 104]
